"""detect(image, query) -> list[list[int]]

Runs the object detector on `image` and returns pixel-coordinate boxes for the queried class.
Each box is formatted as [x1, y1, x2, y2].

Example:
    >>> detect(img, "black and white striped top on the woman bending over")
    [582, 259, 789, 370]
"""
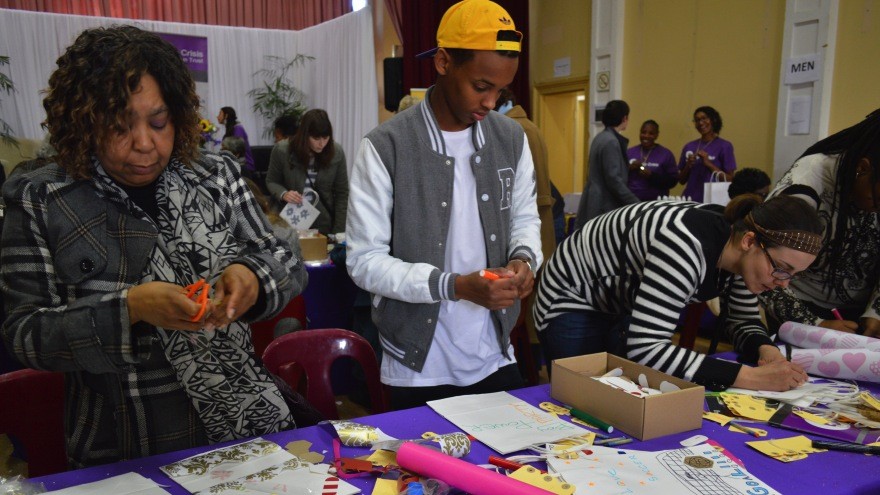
[534, 201, 772, 389]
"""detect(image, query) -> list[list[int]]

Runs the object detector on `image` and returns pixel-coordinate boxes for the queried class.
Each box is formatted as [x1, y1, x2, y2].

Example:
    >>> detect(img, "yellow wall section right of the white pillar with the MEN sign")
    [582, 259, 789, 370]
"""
[828, 0, 880, 133]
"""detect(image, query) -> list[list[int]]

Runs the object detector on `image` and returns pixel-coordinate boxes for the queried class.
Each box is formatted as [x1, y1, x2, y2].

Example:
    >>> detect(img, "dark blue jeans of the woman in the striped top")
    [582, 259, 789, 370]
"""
[538, 311, 630, 369]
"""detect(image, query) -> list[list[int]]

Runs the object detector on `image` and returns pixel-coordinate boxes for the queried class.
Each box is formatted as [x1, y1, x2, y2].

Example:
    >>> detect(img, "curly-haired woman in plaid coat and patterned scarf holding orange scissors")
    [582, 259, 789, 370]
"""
[0, 26, 307, 468]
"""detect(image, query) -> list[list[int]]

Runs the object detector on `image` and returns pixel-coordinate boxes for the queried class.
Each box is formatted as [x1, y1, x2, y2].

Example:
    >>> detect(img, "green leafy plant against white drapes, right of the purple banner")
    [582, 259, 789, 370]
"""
[248, 54, 315, 137]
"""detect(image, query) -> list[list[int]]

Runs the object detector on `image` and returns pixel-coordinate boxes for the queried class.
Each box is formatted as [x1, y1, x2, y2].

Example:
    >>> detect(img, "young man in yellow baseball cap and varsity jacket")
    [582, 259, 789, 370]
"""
[346, 0, 542, 409]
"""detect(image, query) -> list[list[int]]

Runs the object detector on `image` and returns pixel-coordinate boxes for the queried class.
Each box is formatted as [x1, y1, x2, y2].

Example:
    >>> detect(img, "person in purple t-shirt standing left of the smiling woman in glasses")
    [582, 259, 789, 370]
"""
[626, 120, 678, 201]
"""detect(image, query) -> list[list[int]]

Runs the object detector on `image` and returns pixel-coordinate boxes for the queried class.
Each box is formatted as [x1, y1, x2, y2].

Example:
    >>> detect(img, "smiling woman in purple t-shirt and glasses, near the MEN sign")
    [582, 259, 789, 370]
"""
[678, 107, 736, 203]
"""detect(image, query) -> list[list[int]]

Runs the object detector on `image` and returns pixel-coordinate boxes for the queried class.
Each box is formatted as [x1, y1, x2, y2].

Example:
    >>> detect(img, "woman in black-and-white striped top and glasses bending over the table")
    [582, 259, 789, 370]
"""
[534, 195, 822, 390]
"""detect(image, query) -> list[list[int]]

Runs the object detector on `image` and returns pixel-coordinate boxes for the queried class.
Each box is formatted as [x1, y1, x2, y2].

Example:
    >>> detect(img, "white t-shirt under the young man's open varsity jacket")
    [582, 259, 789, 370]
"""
[381, 128, 515, 387]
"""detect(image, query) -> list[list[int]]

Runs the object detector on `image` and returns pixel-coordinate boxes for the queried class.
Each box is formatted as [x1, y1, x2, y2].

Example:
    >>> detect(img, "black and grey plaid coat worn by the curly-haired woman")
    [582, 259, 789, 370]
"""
[0, 154, 307, 467]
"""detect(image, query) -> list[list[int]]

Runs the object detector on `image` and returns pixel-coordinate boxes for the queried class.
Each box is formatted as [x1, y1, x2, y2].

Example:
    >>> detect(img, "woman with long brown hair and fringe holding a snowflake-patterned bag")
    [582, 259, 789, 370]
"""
[266, 108, 348, 235]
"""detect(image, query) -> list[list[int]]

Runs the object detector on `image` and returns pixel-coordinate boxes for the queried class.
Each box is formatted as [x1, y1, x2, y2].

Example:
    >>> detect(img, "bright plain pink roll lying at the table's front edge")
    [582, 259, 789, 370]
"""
[397, 442, 552, 495]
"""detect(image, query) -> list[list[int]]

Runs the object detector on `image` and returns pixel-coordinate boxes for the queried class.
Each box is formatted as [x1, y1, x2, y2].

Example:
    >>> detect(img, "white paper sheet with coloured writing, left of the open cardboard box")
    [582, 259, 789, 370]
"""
[428, 392, 585, 454]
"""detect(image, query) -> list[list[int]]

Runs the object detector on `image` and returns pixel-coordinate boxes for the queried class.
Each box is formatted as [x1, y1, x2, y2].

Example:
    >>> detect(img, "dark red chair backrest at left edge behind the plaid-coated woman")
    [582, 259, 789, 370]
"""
[0, 369, 67, 477]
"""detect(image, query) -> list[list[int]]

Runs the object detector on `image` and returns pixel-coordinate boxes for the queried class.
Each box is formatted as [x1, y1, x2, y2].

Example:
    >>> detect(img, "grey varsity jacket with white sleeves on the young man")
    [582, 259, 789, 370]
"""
[345, 90, 542, 371]
